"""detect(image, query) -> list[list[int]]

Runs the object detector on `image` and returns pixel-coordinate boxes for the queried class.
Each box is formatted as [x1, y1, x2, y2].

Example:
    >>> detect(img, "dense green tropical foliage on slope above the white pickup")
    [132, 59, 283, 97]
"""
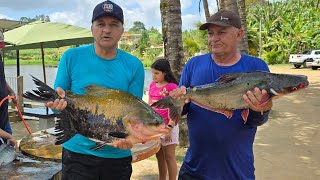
[247, 0, 320, 64]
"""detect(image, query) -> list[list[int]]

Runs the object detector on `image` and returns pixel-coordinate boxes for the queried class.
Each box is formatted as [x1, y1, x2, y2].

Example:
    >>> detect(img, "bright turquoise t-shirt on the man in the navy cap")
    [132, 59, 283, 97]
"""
[54, 44, 144, 158]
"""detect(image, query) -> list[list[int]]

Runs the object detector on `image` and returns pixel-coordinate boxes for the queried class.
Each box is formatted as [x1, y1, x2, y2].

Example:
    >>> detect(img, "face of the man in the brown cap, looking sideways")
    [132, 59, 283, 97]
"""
[208, 25, 243, 56]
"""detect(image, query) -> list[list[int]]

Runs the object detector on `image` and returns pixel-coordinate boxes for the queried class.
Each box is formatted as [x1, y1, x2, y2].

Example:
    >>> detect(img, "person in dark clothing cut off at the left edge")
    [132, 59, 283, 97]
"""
[0, 30, 18, 150]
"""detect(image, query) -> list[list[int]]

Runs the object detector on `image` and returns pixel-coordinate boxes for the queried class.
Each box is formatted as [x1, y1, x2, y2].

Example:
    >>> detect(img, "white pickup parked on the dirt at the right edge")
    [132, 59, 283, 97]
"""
[289, 50, 320, 68]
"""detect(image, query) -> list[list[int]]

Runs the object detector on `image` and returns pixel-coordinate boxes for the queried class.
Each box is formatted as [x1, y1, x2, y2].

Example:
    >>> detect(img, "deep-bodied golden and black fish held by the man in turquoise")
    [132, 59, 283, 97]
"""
[23, 77, 169, 149]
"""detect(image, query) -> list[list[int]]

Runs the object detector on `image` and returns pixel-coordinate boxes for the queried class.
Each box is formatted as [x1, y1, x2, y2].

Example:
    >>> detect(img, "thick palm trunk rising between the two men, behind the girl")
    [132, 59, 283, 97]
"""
[160, 0, 184, 79]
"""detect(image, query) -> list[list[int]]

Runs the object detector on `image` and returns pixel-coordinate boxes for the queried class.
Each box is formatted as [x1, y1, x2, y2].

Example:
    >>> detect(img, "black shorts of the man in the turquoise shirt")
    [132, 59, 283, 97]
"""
[62, 148, 132, 180]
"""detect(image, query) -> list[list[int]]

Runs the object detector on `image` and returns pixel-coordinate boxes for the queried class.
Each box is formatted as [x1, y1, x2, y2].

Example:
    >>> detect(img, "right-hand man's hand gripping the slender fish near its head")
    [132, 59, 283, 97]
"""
[243, 87, 272, 112]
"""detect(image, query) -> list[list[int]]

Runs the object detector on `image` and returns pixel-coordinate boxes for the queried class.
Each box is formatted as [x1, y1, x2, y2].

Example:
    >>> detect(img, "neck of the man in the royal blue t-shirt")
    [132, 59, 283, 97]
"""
[211, 52, 241, 66]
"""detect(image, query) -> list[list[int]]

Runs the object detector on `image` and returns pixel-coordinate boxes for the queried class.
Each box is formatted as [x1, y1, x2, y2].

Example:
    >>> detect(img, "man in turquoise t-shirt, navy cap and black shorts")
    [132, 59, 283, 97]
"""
[46, 1, 144, 180]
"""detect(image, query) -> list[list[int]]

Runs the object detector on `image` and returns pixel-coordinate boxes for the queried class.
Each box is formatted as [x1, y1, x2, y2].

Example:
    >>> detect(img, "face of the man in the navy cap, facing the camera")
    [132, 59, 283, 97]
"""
[91, 16, 124, 49]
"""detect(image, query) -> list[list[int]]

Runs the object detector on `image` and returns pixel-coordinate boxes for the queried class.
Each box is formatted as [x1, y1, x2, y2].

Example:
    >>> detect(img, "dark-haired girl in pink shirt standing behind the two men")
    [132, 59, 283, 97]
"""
[149, 59, 179, 180]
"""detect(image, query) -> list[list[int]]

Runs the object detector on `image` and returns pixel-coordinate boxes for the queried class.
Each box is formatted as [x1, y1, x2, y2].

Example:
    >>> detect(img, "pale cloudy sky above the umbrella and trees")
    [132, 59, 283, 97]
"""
[0, 0, 217, 30]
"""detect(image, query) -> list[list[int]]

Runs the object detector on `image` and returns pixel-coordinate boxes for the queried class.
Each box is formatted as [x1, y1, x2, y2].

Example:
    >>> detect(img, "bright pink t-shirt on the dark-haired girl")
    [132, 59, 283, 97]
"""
[149, 81, 178, 124]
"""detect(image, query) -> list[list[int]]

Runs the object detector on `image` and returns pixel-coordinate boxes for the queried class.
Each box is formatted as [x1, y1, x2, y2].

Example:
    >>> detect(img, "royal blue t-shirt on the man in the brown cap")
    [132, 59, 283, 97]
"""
[179, 54, 269, 180]
